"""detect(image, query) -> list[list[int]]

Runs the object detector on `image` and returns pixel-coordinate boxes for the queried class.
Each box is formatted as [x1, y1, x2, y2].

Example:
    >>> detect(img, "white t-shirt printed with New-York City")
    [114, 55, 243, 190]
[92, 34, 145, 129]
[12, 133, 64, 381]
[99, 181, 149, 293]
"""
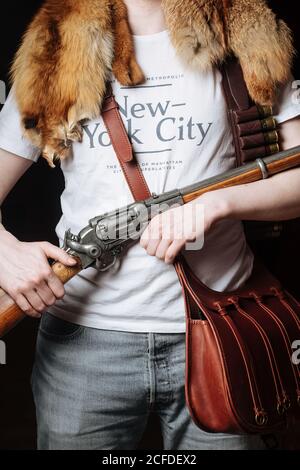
[0, 31, 300, 333]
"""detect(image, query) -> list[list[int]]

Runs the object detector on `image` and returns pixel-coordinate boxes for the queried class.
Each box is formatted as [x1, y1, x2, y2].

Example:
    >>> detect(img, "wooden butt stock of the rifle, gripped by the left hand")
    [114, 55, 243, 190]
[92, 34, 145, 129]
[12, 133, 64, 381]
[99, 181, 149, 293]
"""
[0, 263, 81, 338]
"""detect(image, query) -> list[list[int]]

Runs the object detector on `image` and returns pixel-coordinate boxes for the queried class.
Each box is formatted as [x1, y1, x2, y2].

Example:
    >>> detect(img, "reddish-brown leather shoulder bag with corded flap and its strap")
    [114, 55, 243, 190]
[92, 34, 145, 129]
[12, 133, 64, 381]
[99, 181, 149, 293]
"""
[102, 60, 300, 434]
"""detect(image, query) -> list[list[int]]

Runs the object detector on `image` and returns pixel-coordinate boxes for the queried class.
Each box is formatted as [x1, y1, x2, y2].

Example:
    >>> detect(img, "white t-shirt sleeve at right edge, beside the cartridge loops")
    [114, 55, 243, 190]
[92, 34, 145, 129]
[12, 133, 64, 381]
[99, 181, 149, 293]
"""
[275, 78, 300, 124]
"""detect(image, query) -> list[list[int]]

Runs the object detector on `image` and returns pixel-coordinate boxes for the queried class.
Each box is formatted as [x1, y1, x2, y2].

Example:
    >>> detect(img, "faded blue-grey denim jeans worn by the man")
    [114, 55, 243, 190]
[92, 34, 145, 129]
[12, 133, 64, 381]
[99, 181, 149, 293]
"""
[32, 313, 265, 450]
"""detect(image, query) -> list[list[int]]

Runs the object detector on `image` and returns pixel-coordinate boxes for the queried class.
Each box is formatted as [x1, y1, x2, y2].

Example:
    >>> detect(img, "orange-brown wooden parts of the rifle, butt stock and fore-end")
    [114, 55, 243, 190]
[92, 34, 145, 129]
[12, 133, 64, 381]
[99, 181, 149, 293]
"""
[0, 146, 300, 338]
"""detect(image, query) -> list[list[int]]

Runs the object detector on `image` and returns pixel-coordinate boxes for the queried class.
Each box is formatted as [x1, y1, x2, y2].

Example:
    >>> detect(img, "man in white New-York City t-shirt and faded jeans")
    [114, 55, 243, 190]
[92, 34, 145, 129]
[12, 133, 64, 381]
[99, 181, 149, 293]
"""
[0, 0, 300, 450]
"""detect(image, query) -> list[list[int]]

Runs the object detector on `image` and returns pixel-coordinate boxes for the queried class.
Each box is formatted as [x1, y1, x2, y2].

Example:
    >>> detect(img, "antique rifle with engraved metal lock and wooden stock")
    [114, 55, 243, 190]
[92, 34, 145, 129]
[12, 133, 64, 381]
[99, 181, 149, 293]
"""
[0, 146, 300, 337]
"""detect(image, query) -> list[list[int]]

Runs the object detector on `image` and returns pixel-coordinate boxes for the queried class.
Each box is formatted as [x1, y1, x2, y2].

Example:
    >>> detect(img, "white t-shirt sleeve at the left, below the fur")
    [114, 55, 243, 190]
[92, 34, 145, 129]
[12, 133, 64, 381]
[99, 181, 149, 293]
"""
[0, 88, 41, 162]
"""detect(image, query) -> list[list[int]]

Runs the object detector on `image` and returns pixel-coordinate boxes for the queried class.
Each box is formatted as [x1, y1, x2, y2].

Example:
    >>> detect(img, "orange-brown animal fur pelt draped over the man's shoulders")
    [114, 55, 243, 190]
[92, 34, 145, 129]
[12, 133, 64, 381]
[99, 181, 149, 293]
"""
[11, 0, 293, 166]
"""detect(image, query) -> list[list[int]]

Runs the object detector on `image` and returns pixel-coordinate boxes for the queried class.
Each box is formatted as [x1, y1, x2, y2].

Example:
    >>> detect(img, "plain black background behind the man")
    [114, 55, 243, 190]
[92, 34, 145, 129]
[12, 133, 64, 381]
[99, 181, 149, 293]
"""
[0, 0, 300, 449]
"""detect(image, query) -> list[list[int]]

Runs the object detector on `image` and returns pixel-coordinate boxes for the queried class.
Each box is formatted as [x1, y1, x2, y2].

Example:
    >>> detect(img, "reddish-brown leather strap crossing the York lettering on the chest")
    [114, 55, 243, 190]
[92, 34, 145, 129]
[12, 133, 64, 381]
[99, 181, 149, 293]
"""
[102, 84, 151, 201]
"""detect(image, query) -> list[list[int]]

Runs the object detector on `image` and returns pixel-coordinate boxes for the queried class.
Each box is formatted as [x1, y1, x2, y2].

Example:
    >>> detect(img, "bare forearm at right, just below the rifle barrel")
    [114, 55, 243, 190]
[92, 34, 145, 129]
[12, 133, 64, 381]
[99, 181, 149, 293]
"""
[215, 168, 300, 221]
